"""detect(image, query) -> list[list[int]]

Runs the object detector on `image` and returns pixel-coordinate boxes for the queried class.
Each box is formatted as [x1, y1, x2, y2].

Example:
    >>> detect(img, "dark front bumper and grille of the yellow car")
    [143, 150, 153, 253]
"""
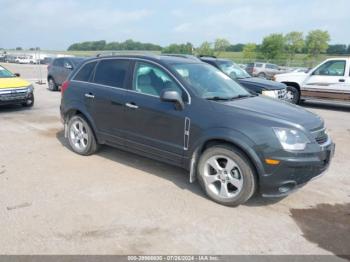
[0, 86, 34, 105]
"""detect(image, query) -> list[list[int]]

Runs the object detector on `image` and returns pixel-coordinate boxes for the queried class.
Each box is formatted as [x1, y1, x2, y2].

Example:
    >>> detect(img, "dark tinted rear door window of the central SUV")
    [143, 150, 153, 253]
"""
[94, 59, 129, 88]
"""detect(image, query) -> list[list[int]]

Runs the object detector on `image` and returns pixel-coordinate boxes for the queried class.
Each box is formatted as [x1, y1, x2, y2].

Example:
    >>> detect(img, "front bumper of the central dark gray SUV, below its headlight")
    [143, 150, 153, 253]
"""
[260, 138, 335, 197]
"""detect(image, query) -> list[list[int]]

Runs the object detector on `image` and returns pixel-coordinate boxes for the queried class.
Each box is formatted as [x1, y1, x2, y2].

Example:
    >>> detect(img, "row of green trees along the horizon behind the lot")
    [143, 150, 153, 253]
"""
[63, 30, 350, 61]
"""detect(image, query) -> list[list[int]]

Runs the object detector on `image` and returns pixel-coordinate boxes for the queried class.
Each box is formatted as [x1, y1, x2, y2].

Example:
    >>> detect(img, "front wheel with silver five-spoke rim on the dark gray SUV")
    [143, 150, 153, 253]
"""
[197, 144, 257, 206]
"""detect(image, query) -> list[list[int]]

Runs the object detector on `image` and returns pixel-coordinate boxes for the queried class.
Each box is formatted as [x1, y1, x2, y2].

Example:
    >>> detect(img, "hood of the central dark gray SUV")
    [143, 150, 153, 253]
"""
[216, 96, 324, 130]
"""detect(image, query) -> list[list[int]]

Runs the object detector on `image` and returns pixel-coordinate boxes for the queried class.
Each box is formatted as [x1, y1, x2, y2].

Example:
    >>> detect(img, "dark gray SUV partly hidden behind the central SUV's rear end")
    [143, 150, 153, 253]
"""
[47, 57, 85, 91]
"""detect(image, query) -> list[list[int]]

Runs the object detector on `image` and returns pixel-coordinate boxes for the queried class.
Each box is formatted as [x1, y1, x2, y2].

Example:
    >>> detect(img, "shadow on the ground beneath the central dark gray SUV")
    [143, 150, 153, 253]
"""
[56, 130, 283, 207]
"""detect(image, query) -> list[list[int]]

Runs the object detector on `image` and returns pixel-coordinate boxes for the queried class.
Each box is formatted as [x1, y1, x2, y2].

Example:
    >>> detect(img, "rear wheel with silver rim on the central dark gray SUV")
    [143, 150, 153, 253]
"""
[67, 115, 98, 156]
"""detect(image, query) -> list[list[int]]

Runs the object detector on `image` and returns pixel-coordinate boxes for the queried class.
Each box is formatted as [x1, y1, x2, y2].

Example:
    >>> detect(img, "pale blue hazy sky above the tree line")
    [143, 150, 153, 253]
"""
[0, 0, 350, 50]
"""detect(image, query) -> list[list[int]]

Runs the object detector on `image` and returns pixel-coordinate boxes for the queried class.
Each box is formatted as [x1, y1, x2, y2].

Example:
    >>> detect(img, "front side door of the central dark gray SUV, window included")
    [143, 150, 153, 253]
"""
[125, 62, 190, 163]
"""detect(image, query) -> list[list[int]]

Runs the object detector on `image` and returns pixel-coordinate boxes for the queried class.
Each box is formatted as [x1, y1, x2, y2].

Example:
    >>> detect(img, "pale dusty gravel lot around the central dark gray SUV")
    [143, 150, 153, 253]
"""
[0, 65, 350, 255]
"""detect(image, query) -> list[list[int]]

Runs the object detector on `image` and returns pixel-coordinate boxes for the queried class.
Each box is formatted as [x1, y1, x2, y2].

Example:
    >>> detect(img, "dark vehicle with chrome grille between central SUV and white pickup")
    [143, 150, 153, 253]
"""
[199, 56, 287, 100]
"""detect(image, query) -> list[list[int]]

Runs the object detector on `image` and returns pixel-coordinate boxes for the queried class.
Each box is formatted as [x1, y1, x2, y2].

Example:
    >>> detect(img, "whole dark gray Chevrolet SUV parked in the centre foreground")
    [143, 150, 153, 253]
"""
[60, 55, 334, 205]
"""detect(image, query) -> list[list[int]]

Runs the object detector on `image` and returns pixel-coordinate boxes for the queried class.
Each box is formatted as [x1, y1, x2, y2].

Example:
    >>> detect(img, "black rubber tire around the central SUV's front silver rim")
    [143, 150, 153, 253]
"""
[197, 144, 257, 206]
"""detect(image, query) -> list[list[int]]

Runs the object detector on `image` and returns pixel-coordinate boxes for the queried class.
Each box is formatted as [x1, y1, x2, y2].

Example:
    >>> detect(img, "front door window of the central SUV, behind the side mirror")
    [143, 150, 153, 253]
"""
[133, 62, 184, 101]
